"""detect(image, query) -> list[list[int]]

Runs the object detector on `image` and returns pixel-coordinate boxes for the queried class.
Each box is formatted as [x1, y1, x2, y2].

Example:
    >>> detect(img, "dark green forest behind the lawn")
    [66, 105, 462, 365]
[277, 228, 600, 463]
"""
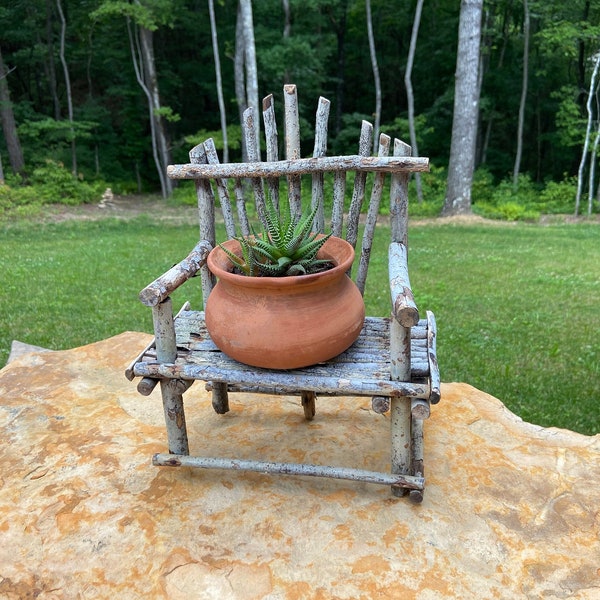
[0, 0, 600, 219]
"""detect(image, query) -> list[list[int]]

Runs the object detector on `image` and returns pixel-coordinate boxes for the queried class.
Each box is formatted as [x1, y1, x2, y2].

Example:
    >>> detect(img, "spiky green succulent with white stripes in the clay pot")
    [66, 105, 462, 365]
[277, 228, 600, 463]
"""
[219, 197, 331, 277]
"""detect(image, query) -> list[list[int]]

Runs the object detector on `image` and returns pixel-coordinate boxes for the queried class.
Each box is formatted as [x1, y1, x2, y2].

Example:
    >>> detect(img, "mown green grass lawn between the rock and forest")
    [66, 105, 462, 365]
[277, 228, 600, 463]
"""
[0, 217, 600, 434]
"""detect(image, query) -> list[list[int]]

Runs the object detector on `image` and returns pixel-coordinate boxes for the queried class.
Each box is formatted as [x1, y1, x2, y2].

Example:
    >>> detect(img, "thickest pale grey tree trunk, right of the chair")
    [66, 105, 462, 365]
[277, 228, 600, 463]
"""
[442, 0, 483, 215]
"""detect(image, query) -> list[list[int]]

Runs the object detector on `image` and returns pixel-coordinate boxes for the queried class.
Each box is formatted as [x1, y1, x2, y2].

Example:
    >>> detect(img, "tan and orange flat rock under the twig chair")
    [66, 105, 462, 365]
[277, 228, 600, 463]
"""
[0, 333, 600, 600]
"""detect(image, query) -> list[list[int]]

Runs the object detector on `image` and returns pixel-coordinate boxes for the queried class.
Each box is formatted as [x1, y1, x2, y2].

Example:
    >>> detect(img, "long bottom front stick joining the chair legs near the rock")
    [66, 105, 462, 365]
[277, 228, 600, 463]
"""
[152, 454, 425, 490]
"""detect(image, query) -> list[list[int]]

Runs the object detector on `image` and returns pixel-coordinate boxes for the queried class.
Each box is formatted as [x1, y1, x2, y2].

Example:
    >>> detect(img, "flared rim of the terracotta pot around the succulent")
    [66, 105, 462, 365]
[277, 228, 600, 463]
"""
[207, 234, 354, 288]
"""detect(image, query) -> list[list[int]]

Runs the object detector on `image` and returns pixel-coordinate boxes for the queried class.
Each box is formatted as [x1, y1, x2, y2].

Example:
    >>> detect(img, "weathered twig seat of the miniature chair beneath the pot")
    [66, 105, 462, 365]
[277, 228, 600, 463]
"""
[132, 310, 439, 403]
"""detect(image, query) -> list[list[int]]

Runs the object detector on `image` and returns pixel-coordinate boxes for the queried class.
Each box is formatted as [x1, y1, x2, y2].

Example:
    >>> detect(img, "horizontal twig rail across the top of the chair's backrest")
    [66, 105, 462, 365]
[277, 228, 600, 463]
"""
[167, 155, 429, 179]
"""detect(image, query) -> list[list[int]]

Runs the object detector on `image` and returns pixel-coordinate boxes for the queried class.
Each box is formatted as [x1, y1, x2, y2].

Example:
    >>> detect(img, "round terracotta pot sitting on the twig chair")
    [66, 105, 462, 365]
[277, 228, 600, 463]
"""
[206, 237, 365, 369]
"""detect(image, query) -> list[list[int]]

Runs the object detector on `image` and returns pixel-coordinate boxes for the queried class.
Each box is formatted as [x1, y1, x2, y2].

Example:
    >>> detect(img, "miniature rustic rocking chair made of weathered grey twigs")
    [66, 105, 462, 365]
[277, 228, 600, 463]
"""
[126, 85, 440, 502]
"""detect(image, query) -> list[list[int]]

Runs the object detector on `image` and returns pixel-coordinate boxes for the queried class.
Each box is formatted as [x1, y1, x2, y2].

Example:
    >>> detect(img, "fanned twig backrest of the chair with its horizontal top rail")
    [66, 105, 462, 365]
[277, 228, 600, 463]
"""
[167, 85, 429, 301]
